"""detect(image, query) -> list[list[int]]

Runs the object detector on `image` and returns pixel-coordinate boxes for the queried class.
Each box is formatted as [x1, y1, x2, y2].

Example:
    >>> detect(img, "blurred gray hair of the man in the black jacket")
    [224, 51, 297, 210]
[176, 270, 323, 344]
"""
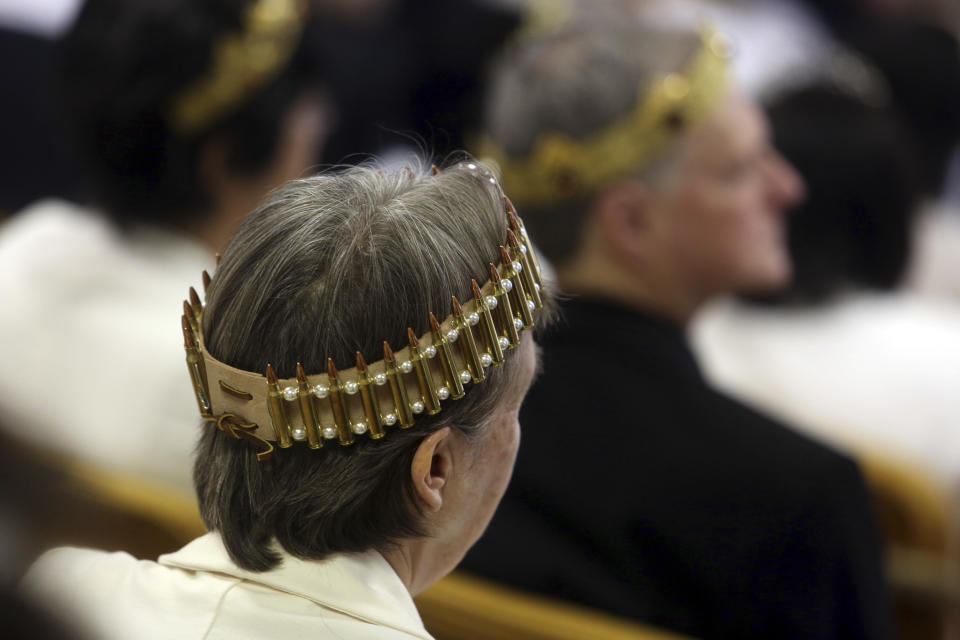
[484, 24, 700, 265]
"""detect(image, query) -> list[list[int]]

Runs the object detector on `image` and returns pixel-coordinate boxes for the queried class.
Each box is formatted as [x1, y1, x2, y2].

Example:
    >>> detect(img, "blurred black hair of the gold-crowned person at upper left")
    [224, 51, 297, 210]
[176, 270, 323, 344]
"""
[60, 0, 320, 225]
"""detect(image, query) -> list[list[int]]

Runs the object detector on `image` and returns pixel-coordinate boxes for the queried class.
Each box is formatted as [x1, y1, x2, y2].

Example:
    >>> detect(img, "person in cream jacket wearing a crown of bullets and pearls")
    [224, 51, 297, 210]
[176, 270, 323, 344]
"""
[25, 162, 552, 640]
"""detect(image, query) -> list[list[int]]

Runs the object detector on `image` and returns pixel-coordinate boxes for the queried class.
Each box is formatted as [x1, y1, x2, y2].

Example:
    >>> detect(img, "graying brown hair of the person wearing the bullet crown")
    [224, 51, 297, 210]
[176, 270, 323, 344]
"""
[194, 162, 544, 570]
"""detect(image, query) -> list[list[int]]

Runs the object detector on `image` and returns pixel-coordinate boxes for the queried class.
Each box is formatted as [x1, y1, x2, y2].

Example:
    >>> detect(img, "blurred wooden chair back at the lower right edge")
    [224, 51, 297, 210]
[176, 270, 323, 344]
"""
[860, 454, 960, 640]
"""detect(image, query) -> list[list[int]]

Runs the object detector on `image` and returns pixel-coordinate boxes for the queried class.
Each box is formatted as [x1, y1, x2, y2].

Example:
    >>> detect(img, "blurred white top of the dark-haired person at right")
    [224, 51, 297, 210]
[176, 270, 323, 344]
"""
[692, 294, 960, 500]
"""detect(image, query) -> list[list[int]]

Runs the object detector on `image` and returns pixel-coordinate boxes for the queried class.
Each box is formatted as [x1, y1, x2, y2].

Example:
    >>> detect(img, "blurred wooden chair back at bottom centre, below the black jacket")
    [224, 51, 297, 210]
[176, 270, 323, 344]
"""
[416, 572, 683, 640]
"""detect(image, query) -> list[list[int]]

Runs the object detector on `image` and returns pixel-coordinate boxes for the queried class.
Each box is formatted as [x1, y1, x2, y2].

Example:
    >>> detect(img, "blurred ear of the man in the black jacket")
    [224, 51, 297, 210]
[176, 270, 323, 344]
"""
[591, 179, 651, 264]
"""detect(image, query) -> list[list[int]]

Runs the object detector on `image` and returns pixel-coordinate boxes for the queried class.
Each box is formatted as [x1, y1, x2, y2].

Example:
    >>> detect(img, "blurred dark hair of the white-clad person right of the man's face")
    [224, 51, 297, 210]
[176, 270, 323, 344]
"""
[766, 86, 921, 303]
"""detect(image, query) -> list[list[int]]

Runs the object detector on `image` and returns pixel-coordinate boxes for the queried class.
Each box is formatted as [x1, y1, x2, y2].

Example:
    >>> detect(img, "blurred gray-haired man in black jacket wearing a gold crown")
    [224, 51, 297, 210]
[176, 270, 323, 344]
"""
[465, 20, 890, 639]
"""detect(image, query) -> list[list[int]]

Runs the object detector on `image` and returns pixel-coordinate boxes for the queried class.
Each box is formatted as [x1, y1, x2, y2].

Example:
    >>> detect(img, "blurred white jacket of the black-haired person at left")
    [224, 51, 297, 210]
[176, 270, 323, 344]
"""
[0, 201, 214, 491]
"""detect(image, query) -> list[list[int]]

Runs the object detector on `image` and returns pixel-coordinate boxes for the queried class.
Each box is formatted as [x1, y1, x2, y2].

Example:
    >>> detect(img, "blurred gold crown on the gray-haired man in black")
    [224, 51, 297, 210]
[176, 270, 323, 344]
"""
[477, 29, 729, 206]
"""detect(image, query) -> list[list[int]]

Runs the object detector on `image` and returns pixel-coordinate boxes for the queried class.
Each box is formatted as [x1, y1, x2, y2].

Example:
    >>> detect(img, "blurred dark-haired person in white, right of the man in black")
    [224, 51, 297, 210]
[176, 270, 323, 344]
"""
[694, 81, 960, 502]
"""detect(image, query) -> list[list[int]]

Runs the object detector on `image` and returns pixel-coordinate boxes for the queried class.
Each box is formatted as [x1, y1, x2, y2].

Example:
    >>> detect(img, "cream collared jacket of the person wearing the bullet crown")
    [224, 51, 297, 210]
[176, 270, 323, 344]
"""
[24, 534, 431, 640]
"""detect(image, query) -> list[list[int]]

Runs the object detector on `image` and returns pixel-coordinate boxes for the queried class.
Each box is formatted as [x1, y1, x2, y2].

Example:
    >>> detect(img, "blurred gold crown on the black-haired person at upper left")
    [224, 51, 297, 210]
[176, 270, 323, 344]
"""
[169, 0, 306, 135]
